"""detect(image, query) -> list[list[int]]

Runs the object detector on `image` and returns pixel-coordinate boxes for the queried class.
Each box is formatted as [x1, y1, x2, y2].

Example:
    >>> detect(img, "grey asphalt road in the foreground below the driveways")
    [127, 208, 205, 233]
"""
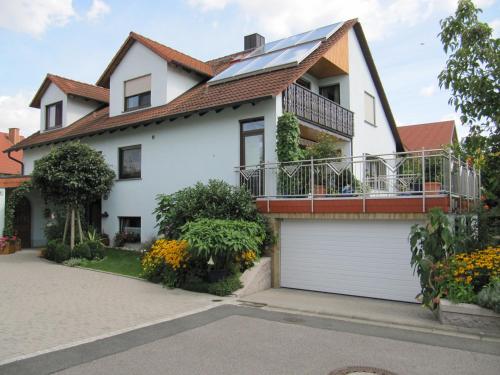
[0, 305, 500, 375]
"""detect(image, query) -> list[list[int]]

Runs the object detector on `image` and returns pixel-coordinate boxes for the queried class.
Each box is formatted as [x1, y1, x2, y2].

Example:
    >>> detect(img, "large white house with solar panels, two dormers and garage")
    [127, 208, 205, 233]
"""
[4, 20, 476, 301]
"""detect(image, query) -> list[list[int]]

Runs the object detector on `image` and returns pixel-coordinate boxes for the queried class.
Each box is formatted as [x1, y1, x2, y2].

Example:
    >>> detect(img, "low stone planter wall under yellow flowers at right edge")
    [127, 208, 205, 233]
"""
[438, 299, 500, 333]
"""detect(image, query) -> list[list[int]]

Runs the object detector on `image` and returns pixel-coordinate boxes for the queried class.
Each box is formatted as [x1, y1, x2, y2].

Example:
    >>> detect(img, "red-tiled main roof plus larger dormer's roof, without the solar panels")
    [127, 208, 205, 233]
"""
[7, 19, 402, 150]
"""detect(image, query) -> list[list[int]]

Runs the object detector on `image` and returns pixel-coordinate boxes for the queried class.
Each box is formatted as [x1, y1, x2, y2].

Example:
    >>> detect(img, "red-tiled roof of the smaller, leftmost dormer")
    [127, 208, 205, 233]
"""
[30, 74, 109, 108]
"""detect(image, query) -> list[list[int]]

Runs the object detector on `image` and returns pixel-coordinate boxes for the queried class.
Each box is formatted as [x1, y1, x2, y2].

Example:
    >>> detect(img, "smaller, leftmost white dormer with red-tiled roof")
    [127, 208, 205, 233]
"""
[30, 74, 109, 132]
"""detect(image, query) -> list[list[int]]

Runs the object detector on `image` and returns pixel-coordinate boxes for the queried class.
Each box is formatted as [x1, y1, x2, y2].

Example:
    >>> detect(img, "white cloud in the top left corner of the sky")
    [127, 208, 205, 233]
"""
[0, 0, 76, 37]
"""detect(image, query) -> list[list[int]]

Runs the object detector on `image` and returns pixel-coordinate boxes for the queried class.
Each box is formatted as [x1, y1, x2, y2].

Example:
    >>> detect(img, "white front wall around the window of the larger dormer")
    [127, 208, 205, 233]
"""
[109, 42, 167, 116]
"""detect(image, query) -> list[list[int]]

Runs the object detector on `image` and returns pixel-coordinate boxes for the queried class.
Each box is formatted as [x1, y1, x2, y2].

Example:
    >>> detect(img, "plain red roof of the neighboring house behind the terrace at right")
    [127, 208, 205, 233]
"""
[398, 120, 457, 151]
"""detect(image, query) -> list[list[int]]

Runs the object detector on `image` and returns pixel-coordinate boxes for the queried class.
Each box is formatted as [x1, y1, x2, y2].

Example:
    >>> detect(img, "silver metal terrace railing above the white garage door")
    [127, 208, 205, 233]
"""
[236, 150, 480, 212]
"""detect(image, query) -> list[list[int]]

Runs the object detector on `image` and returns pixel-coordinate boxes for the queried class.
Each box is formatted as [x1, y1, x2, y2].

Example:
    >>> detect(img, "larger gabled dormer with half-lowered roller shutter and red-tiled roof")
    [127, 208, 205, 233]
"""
[97, 32, 212, 116]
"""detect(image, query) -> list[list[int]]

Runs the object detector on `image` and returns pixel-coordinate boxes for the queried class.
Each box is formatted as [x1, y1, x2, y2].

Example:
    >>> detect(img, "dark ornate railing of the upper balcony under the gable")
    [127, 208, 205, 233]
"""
[283, 83, 354, 137]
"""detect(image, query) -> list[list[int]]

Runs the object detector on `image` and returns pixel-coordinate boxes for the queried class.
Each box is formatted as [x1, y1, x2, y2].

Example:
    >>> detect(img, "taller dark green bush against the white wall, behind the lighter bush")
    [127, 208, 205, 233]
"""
[154, 180, 273, 252]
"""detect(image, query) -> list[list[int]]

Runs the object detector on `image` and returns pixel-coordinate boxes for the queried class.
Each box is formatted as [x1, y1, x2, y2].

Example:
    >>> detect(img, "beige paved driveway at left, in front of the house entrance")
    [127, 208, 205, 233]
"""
[0, 250, 221, 363]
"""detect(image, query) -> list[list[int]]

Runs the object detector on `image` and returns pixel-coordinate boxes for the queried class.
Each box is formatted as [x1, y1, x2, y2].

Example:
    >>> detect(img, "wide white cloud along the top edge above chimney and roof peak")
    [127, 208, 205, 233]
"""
[187, 0, 495, 40]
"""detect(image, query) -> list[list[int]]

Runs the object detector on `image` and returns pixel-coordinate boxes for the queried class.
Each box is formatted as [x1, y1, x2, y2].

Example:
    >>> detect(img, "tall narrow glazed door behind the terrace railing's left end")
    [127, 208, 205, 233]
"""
[240, 118, 264, 196]
